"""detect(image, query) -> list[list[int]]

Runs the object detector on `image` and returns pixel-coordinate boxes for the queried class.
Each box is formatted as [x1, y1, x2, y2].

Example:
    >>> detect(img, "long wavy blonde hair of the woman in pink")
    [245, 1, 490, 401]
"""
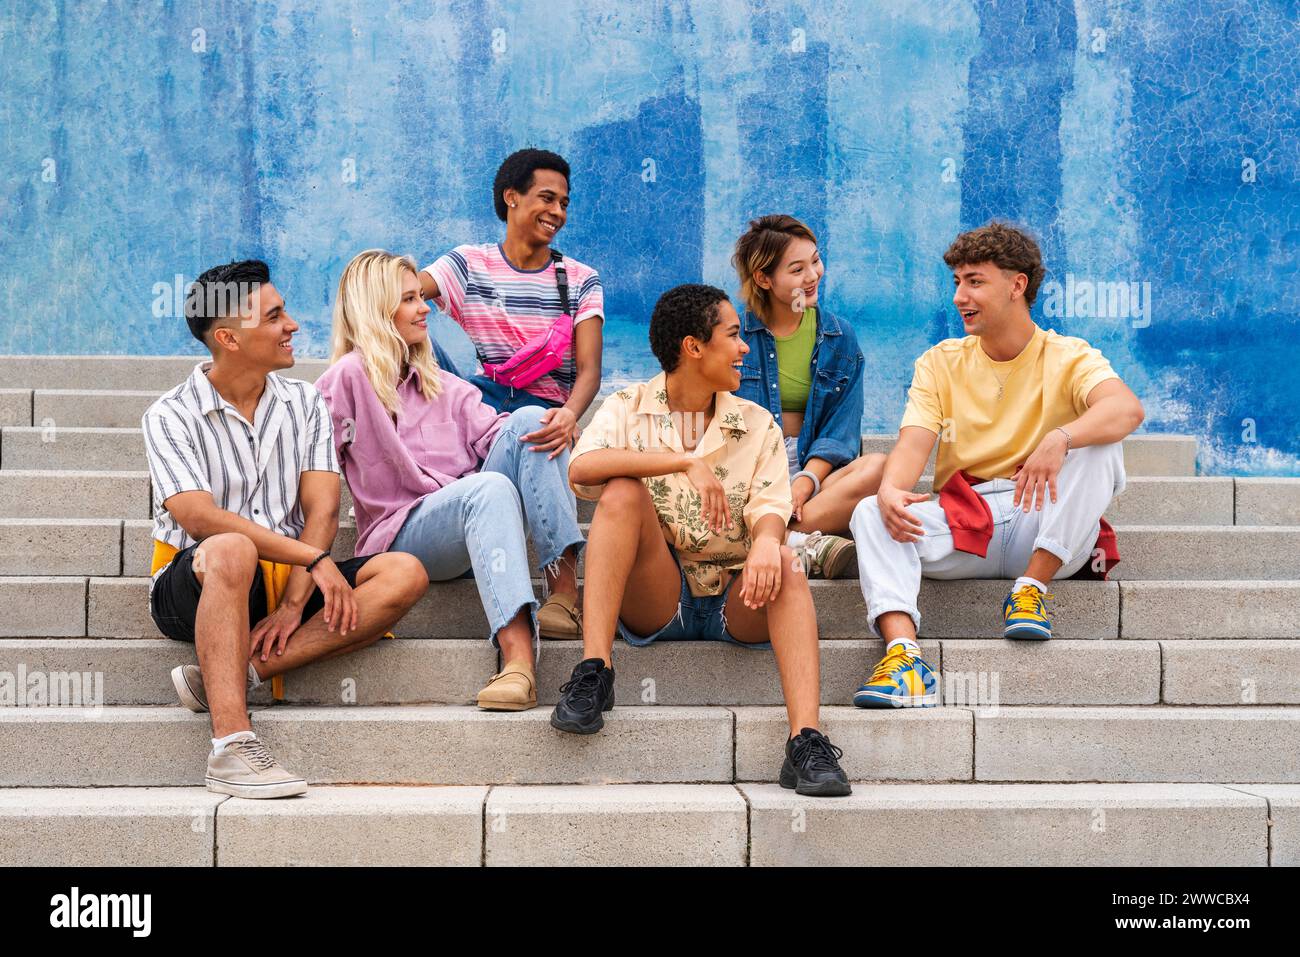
[330, 250, 442, 415]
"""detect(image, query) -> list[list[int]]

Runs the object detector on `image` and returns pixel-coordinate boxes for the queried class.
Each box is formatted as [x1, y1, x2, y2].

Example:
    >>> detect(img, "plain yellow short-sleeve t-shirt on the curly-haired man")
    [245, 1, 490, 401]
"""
[900, 326, 1118, 489]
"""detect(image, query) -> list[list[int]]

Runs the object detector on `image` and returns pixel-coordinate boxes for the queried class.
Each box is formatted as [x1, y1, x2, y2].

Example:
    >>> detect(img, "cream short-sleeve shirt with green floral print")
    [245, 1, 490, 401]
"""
[572, 372, 790, 597]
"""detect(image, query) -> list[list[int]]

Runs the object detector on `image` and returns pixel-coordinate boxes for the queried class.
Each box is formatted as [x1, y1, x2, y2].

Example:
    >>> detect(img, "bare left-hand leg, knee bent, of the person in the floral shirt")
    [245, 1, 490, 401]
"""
[582, 479, 681, 664]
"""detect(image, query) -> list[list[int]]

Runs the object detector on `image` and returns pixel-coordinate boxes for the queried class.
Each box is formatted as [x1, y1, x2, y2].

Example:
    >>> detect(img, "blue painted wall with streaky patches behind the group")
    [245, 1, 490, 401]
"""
[0, 0, 1300, 475]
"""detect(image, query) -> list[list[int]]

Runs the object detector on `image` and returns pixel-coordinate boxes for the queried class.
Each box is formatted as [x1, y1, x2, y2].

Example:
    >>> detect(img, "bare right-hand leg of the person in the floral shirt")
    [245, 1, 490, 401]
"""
[727, 545, 816, 737]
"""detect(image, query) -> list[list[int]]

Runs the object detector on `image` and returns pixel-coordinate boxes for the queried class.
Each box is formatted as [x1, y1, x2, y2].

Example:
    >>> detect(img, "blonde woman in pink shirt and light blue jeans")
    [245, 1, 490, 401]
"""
[316, 250, 582, 711]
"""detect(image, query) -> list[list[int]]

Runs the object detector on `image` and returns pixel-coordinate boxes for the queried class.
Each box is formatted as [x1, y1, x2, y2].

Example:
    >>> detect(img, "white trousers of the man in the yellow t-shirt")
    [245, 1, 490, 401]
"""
[849, 442, 1125, 637]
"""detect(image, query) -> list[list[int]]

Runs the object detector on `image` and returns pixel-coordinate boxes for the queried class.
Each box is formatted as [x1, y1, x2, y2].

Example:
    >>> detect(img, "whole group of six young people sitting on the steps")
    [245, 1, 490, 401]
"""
[142, 143, 1143, 797]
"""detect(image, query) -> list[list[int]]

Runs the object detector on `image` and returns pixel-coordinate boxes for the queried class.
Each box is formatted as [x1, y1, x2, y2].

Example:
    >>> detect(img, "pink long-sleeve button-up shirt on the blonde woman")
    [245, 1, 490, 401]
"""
[316, 351, 508, 555]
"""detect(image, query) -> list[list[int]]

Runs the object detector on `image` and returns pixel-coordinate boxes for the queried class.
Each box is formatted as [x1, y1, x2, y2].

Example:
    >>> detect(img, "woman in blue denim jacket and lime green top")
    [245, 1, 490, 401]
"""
[732, 215, 885, 579]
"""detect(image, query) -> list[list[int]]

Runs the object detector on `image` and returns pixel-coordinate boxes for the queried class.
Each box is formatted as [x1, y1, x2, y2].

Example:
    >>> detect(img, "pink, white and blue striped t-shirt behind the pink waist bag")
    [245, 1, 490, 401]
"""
[424, 243, 605, 404]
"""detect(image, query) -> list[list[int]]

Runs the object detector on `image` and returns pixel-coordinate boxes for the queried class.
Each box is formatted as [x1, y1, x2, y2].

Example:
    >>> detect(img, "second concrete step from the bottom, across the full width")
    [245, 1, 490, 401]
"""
[0, 705, 1300, 788]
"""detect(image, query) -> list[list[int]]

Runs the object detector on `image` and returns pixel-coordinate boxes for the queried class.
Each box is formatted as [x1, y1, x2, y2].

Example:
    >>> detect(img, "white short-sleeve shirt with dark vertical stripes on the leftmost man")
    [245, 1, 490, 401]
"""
[140, 360, 338, 561]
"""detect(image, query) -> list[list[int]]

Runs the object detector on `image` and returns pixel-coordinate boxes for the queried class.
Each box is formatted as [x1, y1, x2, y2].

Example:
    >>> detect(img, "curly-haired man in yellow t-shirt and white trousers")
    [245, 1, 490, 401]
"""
[850, 222, 1144, 707]
